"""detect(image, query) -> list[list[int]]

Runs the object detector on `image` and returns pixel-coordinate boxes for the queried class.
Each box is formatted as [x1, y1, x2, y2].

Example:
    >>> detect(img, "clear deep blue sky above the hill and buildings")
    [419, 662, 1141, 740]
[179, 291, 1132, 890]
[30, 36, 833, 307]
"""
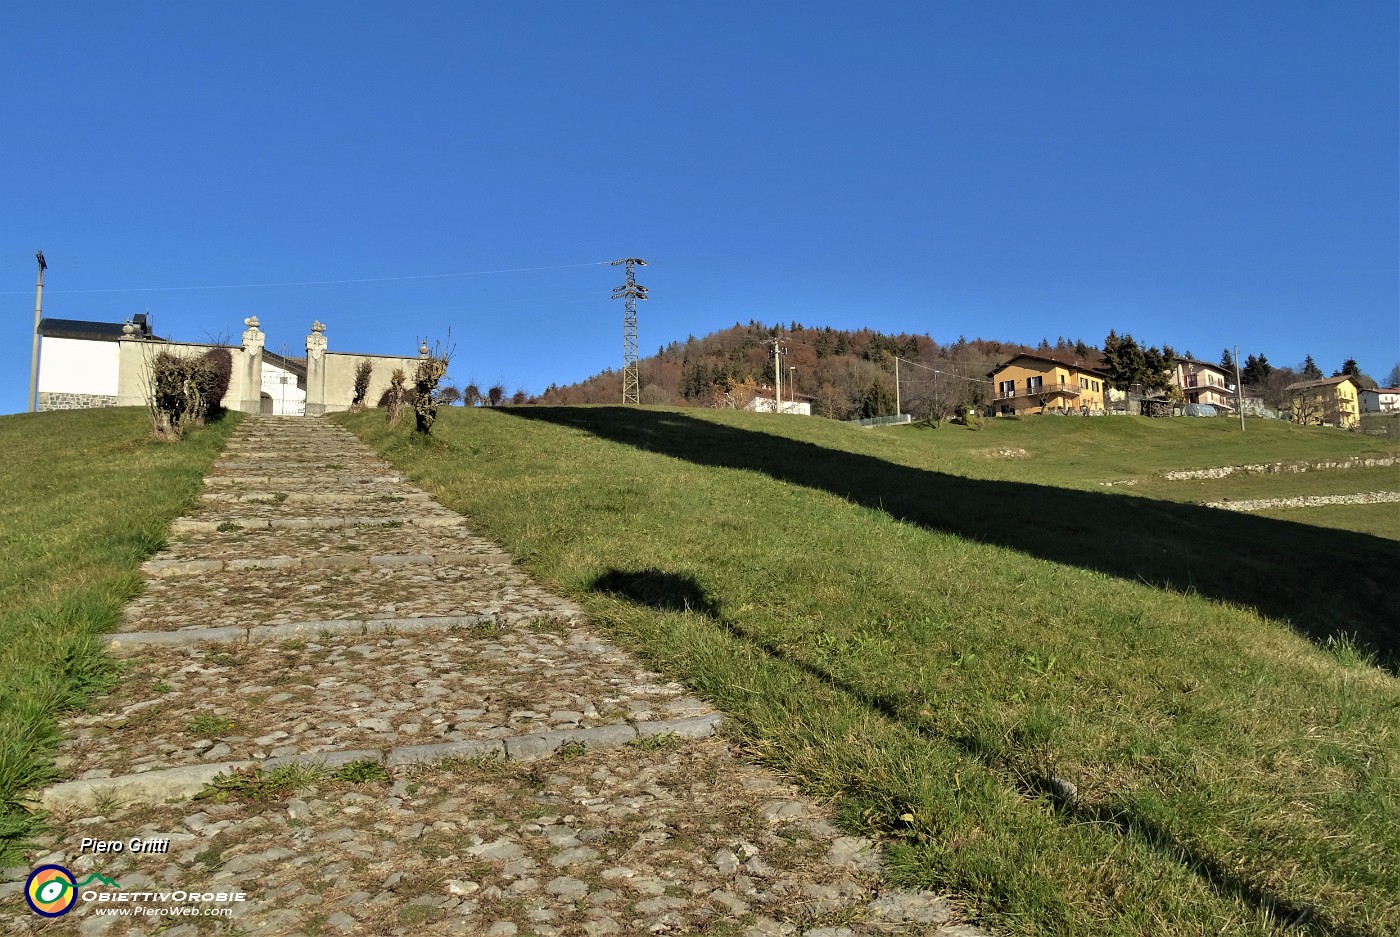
[0, 0, 1400, 412]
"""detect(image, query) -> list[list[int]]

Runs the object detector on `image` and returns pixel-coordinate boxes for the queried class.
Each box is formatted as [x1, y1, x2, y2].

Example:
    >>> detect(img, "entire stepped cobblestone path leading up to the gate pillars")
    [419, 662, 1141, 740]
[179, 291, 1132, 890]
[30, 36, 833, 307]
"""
[0, 417, 983, 937]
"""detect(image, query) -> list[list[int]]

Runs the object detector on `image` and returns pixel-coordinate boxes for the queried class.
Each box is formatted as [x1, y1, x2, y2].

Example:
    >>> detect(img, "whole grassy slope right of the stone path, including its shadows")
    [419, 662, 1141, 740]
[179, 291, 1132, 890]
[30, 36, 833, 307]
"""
[337, 408, 1400, 937]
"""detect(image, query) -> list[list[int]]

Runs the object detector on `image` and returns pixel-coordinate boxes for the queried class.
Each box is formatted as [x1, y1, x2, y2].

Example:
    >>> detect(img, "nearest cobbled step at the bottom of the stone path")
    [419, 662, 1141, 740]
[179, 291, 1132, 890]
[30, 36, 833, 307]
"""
[19, 738, 983, 937]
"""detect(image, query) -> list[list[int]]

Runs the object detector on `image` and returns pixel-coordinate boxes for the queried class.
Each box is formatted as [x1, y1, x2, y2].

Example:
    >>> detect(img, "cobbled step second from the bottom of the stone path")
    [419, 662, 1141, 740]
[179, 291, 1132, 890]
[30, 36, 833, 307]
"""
[57, 622, 713, 779]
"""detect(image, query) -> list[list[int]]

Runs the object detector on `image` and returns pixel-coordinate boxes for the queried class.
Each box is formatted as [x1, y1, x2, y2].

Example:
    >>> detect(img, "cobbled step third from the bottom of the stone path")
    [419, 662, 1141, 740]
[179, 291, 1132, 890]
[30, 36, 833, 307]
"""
[122, 557, 578, 632]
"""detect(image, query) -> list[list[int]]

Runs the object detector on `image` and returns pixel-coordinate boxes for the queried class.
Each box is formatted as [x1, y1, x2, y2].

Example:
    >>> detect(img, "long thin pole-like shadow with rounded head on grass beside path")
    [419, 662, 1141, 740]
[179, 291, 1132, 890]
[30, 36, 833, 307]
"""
[589, 569, 1378, 937]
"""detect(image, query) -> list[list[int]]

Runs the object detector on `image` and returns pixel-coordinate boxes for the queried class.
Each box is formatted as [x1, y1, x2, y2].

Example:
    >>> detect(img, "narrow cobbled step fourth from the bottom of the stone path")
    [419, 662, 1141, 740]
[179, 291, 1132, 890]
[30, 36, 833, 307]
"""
[151, 524, 511, 566]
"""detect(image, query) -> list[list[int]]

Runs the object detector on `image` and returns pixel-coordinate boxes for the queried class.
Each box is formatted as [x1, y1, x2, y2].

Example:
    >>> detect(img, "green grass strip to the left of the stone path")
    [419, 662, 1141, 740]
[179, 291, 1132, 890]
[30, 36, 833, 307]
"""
[0, 408, 235, 866]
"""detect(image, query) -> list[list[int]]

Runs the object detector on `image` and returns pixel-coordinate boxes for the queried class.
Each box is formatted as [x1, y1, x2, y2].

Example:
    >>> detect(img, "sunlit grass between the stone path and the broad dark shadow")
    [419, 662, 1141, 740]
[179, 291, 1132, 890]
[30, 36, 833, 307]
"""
[344, 410, 1400, 937]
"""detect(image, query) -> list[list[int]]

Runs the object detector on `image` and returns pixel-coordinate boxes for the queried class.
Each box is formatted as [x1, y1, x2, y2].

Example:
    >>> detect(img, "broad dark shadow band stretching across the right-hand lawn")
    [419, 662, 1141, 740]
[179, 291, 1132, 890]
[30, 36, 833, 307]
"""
[501, 406, 1400, 675]
